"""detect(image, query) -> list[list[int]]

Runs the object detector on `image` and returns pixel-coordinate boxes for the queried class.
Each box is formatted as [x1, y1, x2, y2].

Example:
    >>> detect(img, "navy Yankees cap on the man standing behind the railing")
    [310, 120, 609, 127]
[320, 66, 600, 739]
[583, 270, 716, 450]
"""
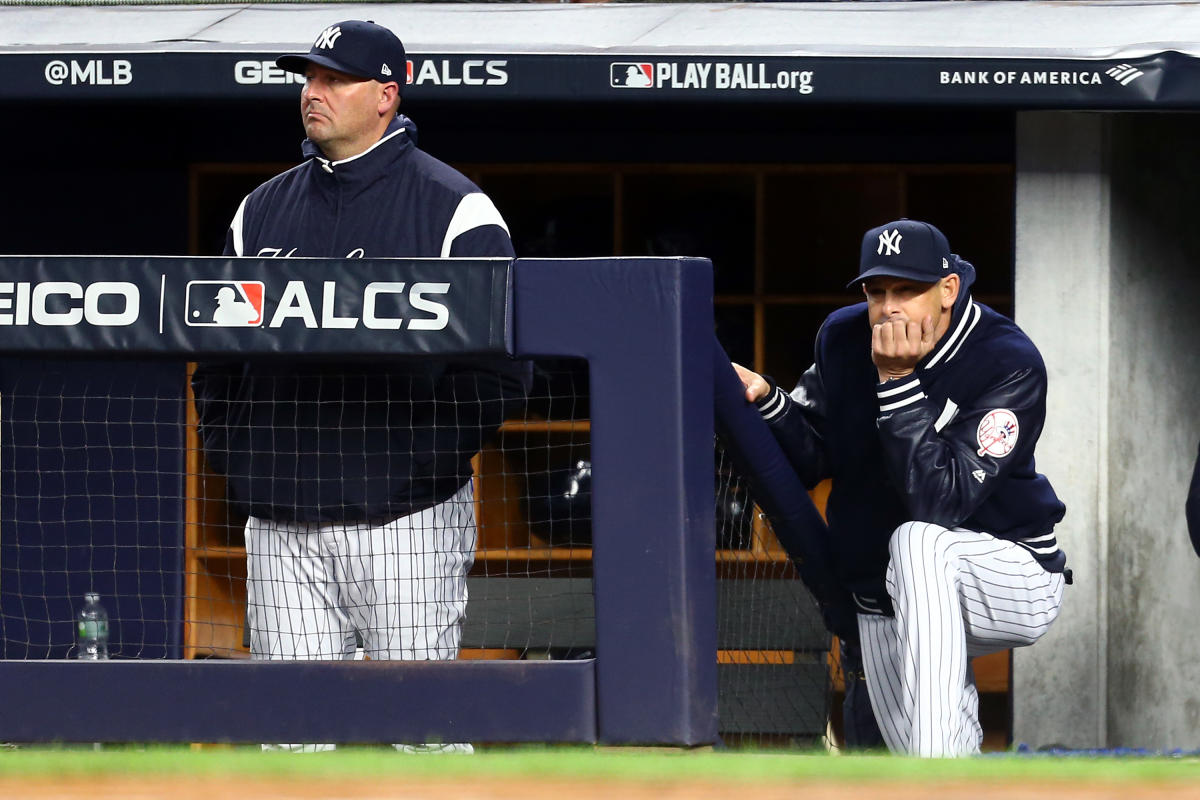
[275, 19, 408, 92]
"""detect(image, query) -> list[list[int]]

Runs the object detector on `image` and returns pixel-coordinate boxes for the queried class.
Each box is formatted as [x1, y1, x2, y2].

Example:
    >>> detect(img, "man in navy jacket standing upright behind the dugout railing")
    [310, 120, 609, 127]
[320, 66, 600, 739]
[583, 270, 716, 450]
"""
[193, 20, 528, 748]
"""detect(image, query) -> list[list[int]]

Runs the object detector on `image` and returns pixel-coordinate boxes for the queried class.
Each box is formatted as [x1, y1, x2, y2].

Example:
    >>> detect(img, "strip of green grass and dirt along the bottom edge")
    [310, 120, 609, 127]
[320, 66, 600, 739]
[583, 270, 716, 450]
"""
[0, 747, 1200, 800]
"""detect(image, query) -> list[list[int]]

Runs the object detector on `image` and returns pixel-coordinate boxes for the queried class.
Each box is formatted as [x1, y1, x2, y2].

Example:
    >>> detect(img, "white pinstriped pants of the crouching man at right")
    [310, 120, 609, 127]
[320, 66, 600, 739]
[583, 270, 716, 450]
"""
[858, 522, 1064, 757]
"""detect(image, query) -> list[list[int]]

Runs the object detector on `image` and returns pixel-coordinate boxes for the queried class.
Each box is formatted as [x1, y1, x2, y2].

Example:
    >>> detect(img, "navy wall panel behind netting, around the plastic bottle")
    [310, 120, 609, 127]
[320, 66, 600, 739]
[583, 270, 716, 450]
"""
[0, 359, 185, 658]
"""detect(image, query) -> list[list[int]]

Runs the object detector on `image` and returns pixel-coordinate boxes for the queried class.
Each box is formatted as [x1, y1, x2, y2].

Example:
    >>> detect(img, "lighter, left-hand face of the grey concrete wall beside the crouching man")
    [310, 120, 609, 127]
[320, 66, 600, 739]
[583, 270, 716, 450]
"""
[1013, 114, 1110, 746]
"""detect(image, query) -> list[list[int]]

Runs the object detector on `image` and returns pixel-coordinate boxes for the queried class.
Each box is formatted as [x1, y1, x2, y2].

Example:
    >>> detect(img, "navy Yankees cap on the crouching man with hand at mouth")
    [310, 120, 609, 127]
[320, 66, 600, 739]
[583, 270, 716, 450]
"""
[846, 219, 953, 289]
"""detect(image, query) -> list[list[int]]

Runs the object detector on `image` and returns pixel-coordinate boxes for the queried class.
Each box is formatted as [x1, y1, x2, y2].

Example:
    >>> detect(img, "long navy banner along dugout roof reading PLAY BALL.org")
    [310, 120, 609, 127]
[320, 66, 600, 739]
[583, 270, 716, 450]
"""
[0, 52, 1200, 110]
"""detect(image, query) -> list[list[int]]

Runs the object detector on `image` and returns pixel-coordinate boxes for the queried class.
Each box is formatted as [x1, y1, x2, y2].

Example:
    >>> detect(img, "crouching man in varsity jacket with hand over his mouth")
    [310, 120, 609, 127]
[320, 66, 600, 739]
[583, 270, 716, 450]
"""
[734, 219, 1070, 757]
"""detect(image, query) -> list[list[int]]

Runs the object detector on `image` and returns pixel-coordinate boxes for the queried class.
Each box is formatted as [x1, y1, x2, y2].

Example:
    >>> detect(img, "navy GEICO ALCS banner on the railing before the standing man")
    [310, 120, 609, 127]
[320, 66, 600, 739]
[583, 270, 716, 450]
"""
[0, 257, 512, 357]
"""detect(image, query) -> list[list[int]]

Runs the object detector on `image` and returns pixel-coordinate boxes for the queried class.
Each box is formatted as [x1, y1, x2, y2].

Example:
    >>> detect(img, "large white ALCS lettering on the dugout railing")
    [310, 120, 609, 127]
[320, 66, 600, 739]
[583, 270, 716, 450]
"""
[266, 281, 450, 331]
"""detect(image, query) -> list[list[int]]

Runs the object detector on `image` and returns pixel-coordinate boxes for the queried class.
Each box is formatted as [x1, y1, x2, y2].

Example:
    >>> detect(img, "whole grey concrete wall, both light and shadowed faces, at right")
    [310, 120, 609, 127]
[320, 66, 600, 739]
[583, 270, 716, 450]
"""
[1014, 113, 1200, 748]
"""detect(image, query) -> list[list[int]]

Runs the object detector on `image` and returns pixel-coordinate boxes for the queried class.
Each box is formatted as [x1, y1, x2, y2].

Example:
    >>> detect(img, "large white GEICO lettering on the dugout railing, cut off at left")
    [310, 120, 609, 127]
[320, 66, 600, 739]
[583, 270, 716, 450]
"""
[0, 281, 142, 326]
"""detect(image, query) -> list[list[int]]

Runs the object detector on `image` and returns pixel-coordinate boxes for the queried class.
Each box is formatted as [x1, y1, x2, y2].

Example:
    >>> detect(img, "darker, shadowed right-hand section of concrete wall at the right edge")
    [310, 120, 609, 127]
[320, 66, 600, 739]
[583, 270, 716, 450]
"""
[1108, 114, 1200, 747]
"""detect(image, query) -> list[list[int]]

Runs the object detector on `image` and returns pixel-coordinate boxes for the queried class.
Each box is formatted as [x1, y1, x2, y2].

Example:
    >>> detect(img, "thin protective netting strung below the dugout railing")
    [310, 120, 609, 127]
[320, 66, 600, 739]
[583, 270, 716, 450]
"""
[0, 359, 829, 744]
